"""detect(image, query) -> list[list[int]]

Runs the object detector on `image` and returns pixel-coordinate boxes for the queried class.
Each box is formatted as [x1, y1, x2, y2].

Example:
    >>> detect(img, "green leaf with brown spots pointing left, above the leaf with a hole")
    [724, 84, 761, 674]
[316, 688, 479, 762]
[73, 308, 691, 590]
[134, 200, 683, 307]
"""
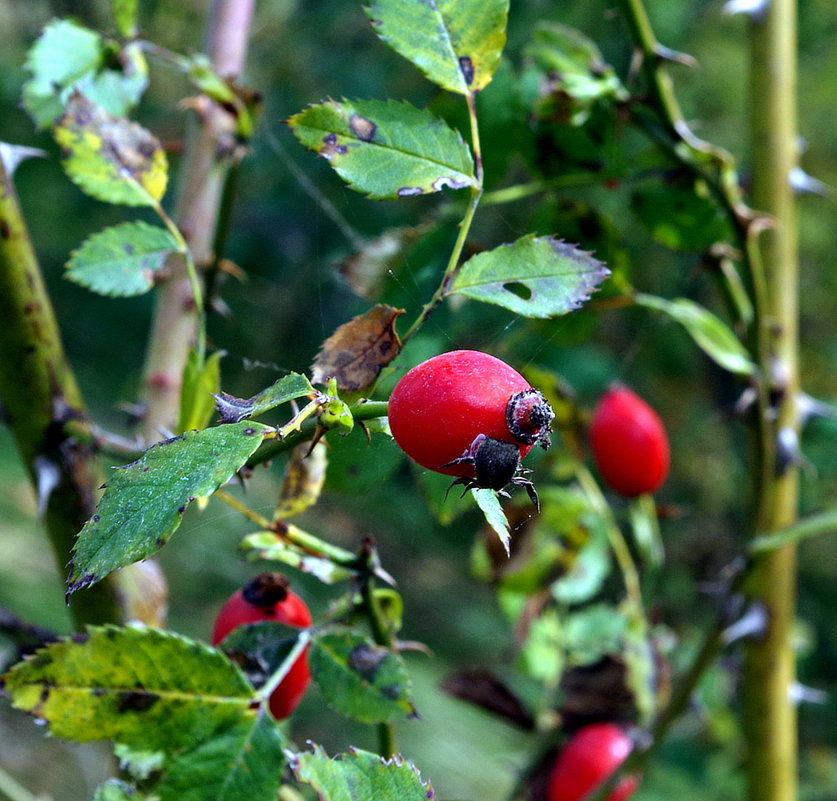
[288, 100, 476, 200]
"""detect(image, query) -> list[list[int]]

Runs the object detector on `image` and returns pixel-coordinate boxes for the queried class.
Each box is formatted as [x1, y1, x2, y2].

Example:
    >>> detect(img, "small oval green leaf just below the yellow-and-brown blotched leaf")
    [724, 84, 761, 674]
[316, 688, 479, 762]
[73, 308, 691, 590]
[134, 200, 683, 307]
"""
[66, 222, 180, 297]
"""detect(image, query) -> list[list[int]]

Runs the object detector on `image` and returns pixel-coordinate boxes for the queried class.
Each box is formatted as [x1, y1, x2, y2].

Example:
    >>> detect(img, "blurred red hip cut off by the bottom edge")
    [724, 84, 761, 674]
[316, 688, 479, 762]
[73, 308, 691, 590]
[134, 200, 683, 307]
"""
[547, 723, 639, 801]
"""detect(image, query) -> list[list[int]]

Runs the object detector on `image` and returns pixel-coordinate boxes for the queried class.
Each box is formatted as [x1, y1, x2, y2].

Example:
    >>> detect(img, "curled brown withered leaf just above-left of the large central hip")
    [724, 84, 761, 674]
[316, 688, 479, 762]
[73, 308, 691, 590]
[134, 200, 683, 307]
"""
[311, 303, 404, 392]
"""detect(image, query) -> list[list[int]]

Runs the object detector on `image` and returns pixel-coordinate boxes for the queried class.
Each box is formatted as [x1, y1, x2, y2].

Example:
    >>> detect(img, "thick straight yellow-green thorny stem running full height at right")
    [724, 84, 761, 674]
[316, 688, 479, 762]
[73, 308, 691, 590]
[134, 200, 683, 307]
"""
[743, 0, 800, 801]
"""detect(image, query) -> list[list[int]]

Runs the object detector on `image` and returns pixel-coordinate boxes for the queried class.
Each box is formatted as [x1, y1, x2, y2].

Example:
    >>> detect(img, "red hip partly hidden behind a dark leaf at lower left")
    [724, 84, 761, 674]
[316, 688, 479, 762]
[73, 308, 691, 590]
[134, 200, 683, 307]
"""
[212, 573, 312, 720]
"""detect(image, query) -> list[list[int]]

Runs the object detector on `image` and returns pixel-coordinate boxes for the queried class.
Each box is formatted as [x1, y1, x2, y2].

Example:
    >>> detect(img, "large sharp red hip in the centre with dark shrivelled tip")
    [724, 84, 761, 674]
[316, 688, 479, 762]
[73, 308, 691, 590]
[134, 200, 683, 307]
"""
[389, 350, 554, 504]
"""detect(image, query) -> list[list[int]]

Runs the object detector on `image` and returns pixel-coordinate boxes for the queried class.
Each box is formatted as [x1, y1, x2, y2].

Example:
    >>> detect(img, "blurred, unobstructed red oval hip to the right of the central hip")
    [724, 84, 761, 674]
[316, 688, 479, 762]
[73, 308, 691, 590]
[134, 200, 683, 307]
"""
[589, 384, 669, 498]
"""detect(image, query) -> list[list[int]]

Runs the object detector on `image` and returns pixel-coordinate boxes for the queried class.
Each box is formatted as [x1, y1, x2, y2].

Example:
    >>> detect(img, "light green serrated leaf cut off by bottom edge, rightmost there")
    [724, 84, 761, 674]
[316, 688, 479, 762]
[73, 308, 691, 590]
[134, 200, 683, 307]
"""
[291, 746, 436, 801]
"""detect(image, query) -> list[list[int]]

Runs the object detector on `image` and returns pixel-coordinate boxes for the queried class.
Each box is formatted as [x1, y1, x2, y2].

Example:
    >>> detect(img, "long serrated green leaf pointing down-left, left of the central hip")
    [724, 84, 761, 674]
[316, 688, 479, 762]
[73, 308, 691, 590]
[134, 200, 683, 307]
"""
[67, 423, 270, 593]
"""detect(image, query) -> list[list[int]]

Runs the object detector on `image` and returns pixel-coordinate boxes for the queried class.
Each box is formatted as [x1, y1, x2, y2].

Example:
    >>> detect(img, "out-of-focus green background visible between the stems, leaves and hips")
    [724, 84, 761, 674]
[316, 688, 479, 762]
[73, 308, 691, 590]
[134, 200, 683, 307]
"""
[0, 0, 837, 801]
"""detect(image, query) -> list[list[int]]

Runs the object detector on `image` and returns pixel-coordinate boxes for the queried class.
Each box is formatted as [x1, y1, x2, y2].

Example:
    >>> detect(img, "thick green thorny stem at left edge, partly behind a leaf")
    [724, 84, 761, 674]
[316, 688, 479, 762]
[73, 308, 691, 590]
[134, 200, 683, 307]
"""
[0, 150, 120, 629]
